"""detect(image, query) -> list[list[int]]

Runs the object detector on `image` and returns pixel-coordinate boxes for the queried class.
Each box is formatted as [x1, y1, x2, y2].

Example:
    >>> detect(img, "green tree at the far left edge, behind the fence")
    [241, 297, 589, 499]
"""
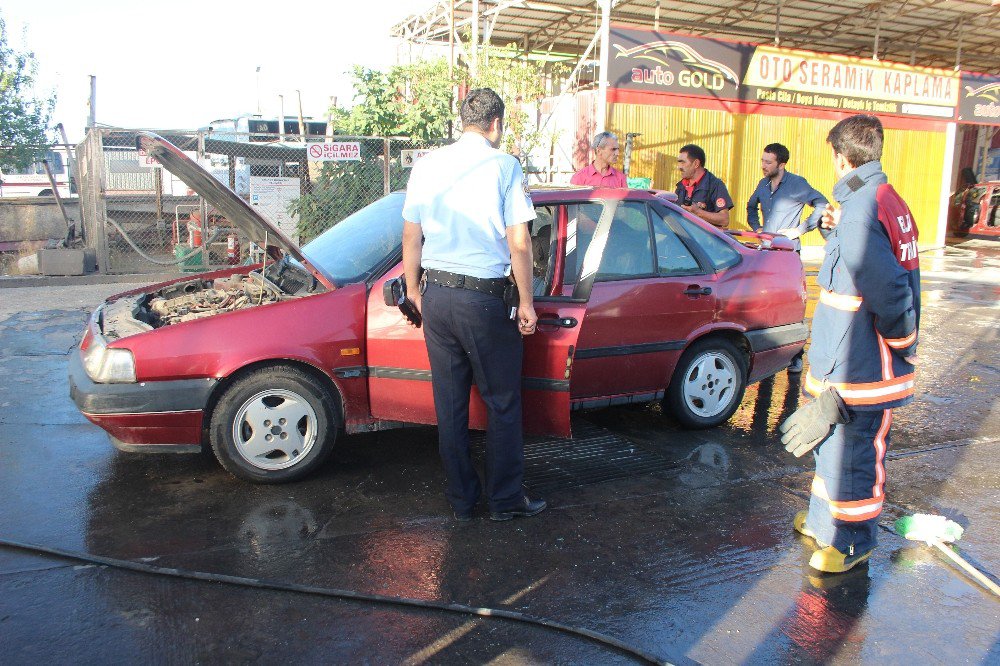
[0, 17, 55, 168]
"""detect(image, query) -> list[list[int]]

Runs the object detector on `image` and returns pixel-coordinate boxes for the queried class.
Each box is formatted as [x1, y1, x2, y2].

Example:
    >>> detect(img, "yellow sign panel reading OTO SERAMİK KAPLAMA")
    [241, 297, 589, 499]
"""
[743, 46, 958, 118]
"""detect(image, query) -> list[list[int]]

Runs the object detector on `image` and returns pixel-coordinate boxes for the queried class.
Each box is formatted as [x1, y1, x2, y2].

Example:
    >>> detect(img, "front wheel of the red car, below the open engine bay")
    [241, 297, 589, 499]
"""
[209, 366, 337, 483]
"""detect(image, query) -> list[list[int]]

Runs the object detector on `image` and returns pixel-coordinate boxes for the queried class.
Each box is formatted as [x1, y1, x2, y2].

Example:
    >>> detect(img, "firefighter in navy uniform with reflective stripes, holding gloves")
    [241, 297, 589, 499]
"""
[779, 115, 920, 573]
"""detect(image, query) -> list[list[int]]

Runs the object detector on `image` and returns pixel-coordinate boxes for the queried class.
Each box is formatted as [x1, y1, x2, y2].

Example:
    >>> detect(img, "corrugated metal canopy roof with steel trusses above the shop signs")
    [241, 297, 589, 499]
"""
[392, 0, 1000, 74]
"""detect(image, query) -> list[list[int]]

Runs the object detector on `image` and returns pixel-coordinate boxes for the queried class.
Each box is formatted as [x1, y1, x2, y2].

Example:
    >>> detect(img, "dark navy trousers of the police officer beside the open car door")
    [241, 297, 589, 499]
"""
[422, 284, 524, 511]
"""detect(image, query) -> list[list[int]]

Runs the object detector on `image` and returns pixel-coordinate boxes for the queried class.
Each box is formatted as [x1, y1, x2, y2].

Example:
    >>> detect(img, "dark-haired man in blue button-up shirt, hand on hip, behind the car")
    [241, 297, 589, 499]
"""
[747, 143, 829, 372]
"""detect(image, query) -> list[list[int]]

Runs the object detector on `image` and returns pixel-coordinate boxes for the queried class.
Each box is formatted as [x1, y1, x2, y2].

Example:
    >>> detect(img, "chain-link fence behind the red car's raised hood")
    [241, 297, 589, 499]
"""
[78, 128, 452, 273]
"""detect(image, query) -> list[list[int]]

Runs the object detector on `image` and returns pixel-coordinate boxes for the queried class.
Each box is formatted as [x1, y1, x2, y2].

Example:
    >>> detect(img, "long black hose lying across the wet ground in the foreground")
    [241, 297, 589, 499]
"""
[0, 539, 669, 666]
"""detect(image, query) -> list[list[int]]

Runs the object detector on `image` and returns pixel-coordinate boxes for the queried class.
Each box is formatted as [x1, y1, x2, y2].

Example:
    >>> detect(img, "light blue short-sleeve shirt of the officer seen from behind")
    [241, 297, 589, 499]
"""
[403, 132, 535, 278]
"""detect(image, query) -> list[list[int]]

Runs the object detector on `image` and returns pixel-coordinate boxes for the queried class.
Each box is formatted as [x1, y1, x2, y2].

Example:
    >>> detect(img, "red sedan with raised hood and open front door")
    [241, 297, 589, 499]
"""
[69, 135, 808, 483]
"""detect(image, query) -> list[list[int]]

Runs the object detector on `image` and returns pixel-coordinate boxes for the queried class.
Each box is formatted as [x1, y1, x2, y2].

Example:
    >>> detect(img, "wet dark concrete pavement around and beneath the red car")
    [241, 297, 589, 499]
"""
[0, 241, 1000, 664]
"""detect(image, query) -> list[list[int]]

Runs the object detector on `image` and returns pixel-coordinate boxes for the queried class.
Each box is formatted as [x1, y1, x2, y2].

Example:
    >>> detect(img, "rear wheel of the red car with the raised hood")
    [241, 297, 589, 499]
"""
[664, 338, 747, 428]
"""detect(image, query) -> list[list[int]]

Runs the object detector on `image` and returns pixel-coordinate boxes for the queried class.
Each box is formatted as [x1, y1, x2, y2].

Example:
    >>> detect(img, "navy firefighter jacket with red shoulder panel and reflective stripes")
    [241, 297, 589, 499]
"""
[803, 161, 920, 411]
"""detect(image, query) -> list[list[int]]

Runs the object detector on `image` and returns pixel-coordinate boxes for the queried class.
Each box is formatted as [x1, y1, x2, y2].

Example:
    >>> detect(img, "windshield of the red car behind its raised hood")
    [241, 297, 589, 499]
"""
[302, 192, 406, 284]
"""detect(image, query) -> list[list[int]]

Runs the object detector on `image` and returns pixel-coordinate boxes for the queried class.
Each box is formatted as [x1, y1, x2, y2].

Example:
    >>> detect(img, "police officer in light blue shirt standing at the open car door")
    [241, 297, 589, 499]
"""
[403, 88, 546, 522]
